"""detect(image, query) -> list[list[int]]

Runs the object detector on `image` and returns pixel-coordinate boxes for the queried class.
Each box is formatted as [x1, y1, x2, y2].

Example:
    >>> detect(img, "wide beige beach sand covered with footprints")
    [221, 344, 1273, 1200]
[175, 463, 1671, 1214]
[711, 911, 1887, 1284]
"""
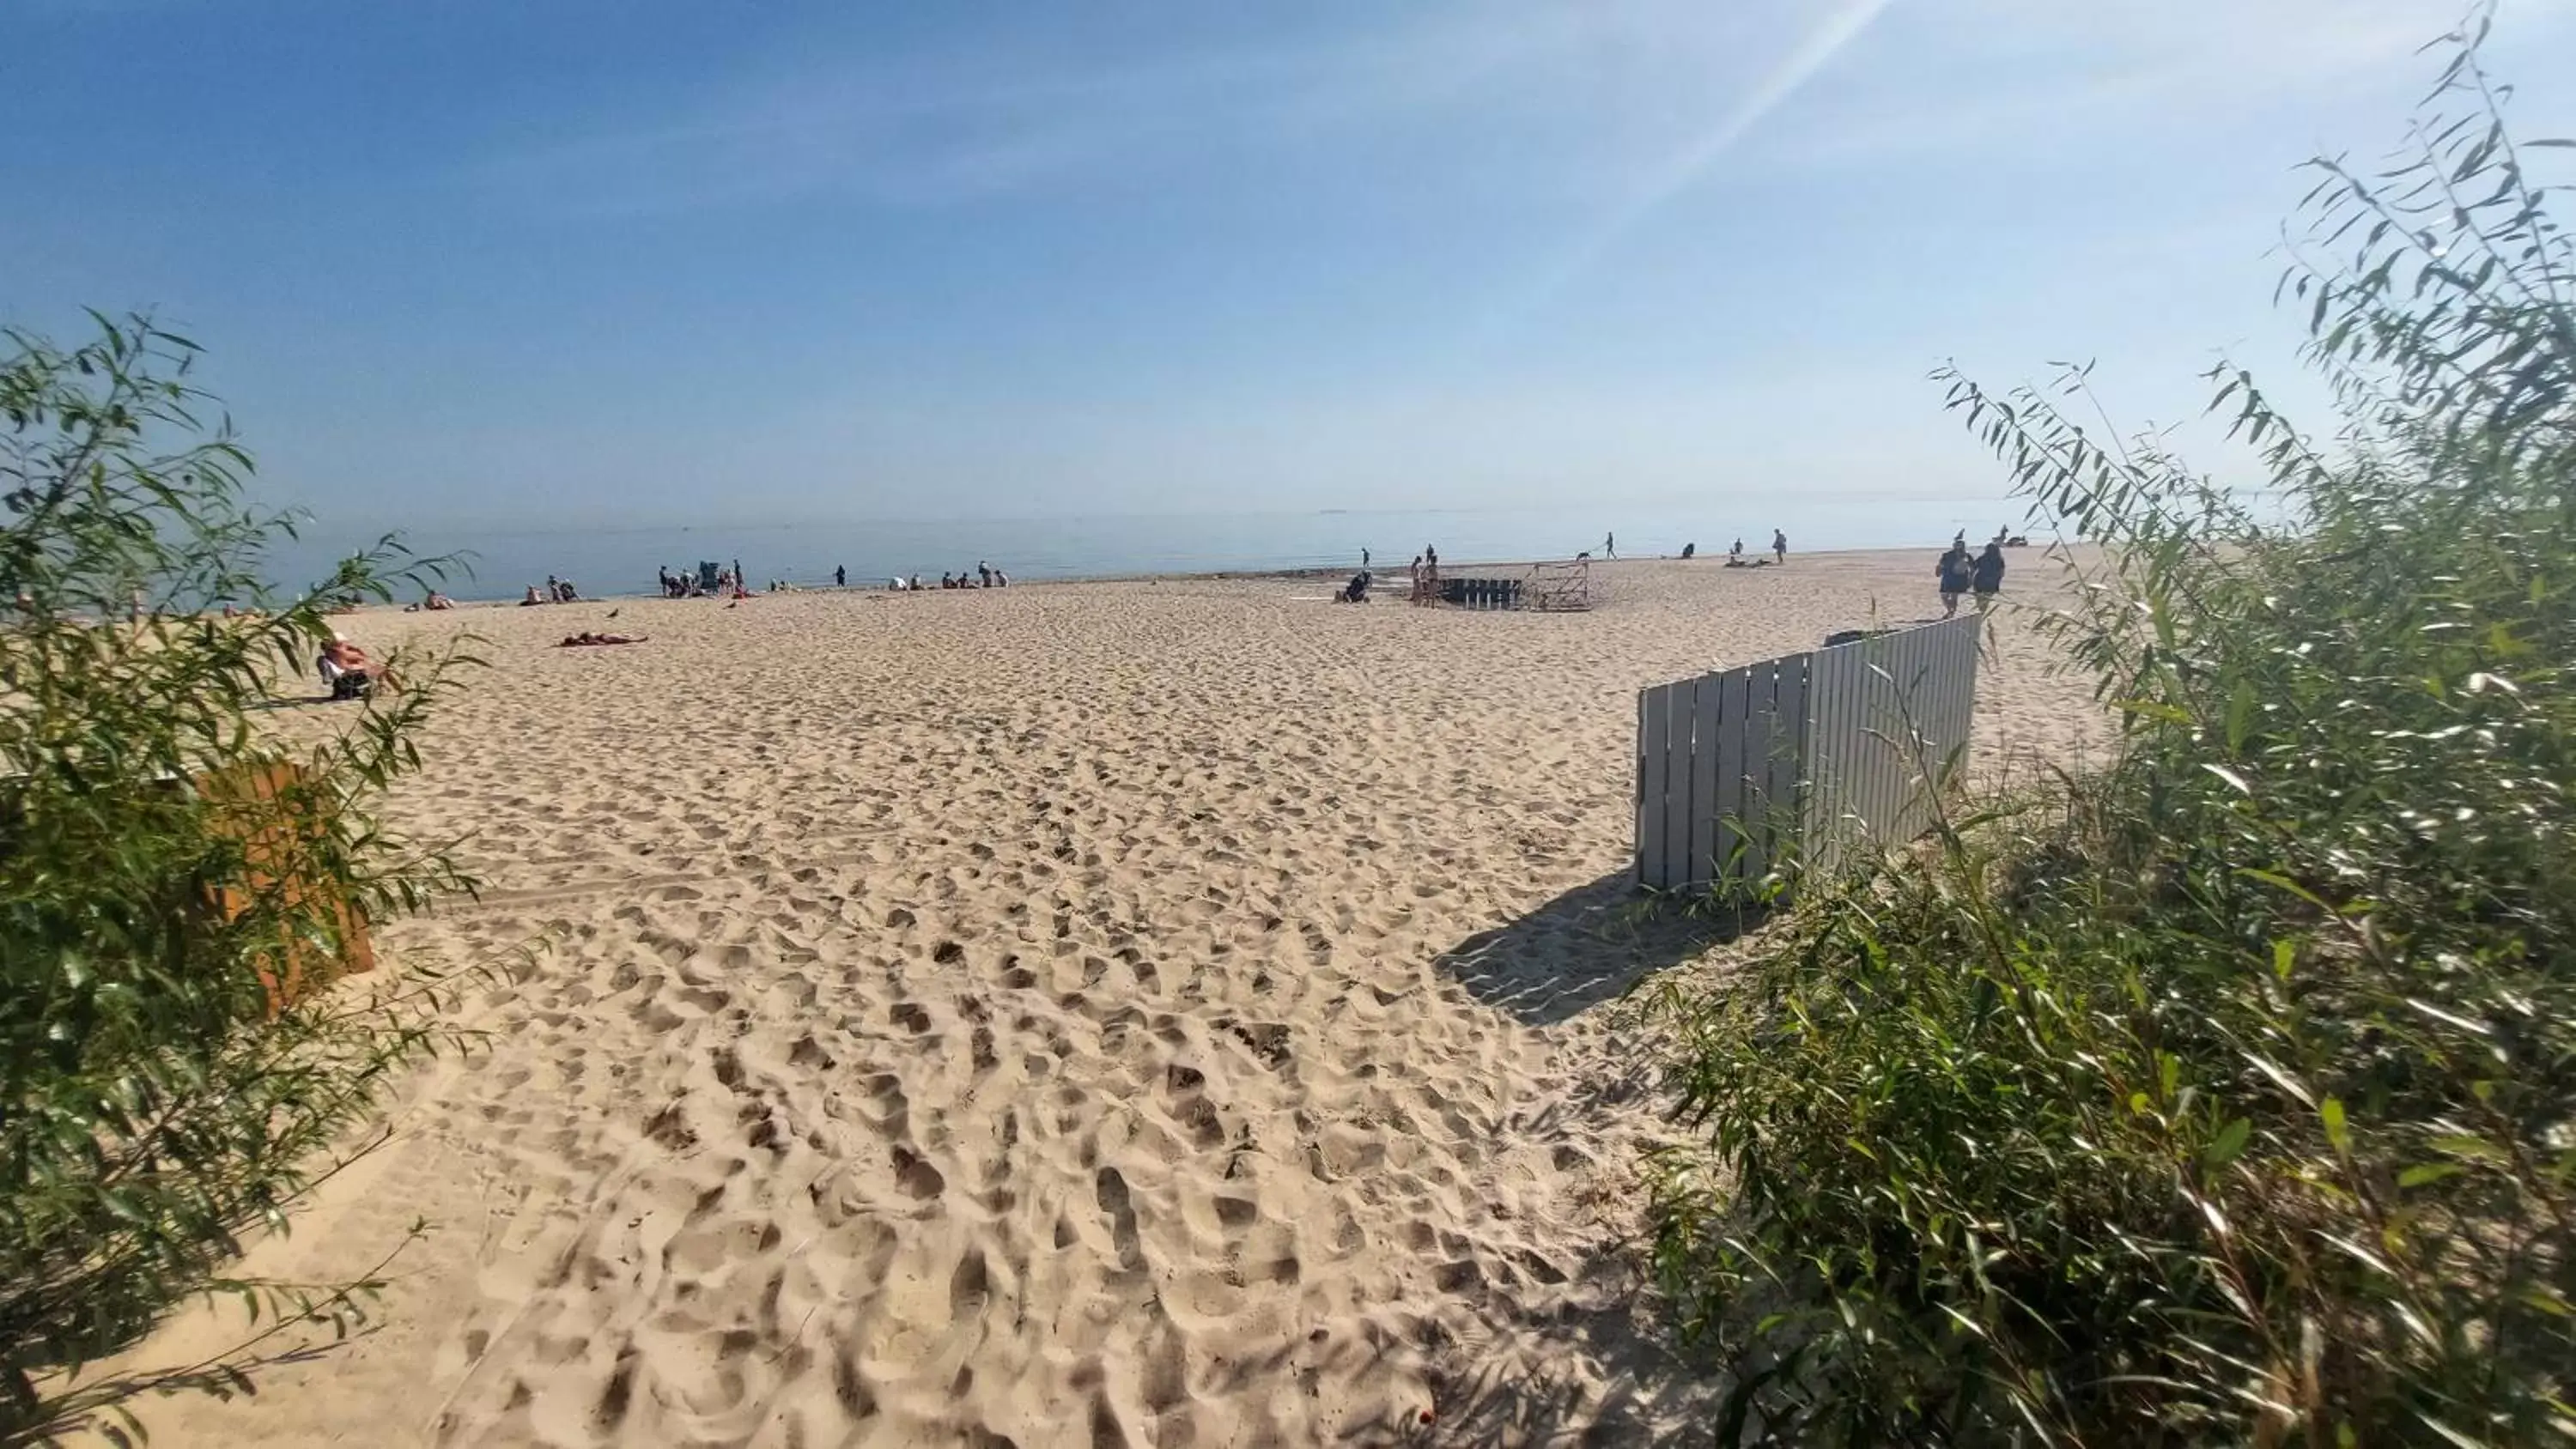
[111, 551, 2102, 1446]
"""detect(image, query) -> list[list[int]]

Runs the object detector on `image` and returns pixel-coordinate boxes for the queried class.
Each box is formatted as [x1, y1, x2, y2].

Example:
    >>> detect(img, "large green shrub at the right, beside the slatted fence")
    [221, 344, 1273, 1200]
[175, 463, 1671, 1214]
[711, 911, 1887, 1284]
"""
[1656, 33, 2576, 1444]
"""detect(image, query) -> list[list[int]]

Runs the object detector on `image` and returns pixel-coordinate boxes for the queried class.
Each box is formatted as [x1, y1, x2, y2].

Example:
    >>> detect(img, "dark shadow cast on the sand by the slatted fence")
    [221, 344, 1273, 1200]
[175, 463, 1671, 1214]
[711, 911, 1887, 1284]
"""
[1440, 870, 1762, 1027]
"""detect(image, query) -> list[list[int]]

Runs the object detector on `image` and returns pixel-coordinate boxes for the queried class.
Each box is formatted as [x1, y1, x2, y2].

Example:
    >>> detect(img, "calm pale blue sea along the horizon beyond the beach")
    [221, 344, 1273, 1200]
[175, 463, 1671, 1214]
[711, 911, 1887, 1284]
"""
[270, 497, 2020, 600]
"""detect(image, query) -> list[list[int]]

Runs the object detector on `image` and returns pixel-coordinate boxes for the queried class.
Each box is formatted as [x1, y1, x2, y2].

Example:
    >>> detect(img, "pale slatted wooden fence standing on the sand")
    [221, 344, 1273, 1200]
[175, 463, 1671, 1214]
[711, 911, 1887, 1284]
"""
[1636, 615, 1978, 893]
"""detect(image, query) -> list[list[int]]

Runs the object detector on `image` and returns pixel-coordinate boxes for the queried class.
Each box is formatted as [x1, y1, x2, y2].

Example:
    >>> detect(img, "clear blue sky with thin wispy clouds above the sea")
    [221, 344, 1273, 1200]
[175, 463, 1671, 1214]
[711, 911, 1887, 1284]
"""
[0, 0, 2576, 525]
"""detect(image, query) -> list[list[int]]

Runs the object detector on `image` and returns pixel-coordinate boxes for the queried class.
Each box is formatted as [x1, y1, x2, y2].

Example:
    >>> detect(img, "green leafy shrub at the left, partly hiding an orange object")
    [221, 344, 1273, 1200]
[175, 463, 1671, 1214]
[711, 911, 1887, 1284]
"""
[0, 319, 487, 1444]
